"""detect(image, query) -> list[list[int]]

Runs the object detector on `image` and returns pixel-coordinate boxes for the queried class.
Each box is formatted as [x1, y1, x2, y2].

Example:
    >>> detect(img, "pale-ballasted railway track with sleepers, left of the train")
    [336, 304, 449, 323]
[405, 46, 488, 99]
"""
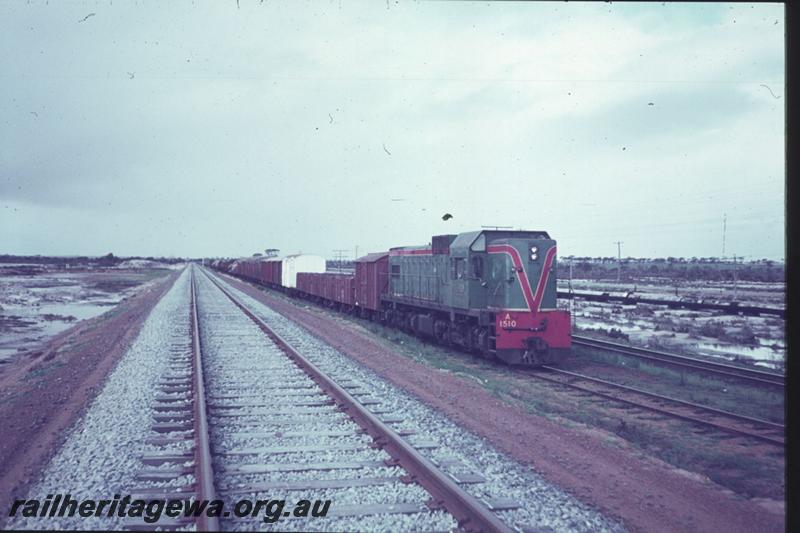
[126, 267, 512, 531]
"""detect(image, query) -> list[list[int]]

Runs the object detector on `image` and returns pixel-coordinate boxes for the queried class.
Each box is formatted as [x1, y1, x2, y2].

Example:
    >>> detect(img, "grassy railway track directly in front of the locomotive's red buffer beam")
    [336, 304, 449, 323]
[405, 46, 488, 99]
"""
[529, 366, 785, 447]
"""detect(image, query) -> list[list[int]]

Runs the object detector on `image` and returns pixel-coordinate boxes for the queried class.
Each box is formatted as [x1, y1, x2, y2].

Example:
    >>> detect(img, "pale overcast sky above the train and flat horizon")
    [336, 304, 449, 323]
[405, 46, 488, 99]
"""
[0, 0, 785, 258]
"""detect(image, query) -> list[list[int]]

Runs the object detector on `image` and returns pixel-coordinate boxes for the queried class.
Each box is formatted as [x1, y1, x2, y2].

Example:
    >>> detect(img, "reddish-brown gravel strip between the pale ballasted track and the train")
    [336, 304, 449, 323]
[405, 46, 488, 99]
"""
[220, 276, 784, 532]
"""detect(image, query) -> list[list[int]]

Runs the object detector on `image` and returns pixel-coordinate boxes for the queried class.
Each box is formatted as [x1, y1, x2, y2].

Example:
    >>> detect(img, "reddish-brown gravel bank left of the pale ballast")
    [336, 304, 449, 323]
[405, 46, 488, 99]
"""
[0, 272, 179, 526]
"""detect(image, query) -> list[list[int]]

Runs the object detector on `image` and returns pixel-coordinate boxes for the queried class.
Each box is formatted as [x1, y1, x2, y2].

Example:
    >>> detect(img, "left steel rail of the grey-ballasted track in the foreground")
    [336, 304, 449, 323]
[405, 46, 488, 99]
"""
[191, 268, 220, 531]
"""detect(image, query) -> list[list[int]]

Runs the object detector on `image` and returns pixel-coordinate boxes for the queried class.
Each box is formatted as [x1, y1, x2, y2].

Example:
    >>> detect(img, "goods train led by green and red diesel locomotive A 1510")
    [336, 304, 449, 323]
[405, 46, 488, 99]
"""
[212, 230, 571, 366]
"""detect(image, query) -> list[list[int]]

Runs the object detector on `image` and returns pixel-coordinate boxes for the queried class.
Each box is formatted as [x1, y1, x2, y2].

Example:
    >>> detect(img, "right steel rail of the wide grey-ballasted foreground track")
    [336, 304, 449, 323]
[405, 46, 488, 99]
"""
[204, 272, 514, 533]
